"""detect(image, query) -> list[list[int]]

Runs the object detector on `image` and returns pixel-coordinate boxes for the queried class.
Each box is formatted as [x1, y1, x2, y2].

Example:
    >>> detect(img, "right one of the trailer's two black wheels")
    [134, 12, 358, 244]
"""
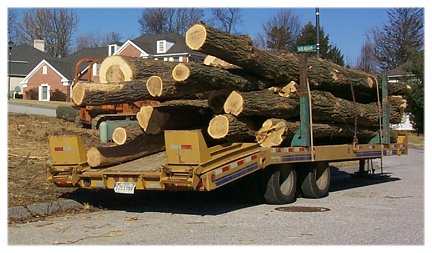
[299, 162, 330, 199]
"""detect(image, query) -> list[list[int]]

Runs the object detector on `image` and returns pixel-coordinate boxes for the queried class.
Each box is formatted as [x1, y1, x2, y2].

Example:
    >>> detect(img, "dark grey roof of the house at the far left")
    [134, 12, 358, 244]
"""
[10, 44, 58, 77]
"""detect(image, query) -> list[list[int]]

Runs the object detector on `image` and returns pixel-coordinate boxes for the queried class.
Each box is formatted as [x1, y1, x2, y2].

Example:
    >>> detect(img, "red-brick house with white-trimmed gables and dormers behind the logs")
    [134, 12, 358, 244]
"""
[21, 33, 205, 101]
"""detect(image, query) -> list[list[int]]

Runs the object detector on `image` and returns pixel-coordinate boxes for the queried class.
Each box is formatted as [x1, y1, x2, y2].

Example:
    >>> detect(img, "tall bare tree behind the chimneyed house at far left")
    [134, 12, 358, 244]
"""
[20, 9, 78, 58]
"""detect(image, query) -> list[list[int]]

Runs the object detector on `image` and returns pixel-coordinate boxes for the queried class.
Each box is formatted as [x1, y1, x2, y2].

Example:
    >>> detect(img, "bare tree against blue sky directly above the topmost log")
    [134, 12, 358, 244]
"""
[212, 8, 242, 33]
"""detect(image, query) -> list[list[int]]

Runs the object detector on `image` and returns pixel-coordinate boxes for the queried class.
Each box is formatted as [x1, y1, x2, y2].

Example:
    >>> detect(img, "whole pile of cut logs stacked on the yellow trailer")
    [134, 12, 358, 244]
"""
[72, 24, 410, 167]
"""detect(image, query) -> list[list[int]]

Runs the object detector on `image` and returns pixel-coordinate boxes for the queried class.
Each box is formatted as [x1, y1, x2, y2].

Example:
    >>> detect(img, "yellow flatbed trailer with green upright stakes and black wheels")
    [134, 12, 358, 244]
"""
[47, 54, 408, 204]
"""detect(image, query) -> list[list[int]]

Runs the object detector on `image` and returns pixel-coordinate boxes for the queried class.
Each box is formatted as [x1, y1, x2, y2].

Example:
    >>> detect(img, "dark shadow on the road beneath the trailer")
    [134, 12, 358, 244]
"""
[63, 167, 400, 215]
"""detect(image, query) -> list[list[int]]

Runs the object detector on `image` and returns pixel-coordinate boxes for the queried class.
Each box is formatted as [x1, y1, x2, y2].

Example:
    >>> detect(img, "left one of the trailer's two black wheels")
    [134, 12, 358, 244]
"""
[264, 165, 297, 205]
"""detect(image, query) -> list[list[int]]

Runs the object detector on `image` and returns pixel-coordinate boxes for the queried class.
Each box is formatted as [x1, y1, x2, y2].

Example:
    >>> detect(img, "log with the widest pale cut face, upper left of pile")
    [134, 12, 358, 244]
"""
[99, 55, 176, 83]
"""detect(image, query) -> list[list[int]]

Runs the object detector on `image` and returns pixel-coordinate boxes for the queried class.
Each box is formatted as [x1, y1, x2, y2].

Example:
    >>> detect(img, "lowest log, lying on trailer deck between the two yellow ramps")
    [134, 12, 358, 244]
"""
[87, 133, 165, 168]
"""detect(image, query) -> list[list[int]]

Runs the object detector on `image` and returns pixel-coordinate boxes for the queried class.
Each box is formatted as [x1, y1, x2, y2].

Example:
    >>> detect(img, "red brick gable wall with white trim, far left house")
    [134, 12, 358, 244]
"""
[23, 64, 69, 99]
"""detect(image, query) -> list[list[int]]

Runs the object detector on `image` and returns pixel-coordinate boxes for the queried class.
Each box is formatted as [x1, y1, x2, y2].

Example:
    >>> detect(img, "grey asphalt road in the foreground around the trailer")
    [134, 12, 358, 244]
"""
[8, 149, 425, 245]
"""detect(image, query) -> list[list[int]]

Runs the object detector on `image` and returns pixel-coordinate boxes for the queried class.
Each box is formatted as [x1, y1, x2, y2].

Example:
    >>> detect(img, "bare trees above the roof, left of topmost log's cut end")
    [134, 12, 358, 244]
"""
[138, 8, 204, 35]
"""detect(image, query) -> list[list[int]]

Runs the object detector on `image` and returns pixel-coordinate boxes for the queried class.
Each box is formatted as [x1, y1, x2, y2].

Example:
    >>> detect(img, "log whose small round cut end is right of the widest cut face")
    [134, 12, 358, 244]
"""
[172, 62, 273, 91]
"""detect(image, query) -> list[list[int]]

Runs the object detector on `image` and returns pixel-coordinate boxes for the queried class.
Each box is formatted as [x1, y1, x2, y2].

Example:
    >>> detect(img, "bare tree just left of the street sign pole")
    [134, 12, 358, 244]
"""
[263, 9, 301, 50]
